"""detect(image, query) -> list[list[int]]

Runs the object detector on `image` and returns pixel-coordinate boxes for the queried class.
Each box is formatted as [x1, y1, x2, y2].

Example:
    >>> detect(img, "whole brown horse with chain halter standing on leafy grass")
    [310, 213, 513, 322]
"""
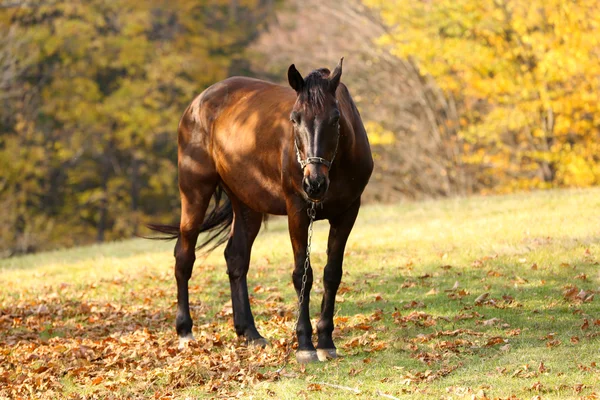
[150, 59, 373, 362]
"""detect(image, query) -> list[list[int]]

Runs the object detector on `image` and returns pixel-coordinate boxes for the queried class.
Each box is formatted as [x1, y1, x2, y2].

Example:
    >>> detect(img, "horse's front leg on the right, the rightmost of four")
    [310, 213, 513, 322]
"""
[317, 198, 360, 361]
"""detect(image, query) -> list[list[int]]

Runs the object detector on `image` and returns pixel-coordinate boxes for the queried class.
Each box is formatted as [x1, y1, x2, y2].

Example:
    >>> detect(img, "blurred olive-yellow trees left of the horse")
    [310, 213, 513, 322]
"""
[0, 0, 273, 254]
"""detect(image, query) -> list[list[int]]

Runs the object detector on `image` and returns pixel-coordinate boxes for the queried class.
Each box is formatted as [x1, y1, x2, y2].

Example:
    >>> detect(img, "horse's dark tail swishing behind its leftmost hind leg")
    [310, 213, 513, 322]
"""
[146, 185, 233, 252]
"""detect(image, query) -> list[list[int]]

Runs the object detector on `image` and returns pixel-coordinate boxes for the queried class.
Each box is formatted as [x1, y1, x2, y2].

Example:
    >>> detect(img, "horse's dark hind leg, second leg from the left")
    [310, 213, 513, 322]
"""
[225, 197, 267, 346]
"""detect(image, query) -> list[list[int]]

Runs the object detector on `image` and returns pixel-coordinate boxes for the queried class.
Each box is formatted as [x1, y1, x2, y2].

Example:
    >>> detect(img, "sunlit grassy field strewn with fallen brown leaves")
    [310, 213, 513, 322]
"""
[0, 189, 600, 399]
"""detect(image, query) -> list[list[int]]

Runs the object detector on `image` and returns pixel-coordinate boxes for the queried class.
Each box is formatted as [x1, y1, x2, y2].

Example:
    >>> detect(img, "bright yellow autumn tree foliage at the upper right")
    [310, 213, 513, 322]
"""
[364, 0, 600, 191]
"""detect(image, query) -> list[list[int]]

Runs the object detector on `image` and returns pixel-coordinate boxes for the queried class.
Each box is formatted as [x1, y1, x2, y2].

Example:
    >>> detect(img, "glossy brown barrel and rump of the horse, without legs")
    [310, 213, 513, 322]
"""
[179, 77, 295, 214]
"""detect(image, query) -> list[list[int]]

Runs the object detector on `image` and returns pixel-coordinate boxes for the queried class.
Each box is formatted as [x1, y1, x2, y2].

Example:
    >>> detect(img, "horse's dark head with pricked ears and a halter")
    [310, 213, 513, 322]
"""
[288, 58, 344, 202]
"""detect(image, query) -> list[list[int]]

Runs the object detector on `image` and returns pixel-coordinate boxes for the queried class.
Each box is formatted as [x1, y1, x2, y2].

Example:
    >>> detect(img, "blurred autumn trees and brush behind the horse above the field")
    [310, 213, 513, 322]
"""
[0, 0, 600, 257]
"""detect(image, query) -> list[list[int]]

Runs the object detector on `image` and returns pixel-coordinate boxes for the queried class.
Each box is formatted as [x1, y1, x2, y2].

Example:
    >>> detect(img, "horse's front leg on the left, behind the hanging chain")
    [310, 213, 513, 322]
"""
[288, 205, 318, 363]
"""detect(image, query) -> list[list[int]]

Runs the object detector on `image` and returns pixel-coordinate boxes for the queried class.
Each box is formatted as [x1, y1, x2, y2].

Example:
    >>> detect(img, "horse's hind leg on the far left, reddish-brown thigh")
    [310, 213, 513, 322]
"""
[175, 175, 217, 347]
